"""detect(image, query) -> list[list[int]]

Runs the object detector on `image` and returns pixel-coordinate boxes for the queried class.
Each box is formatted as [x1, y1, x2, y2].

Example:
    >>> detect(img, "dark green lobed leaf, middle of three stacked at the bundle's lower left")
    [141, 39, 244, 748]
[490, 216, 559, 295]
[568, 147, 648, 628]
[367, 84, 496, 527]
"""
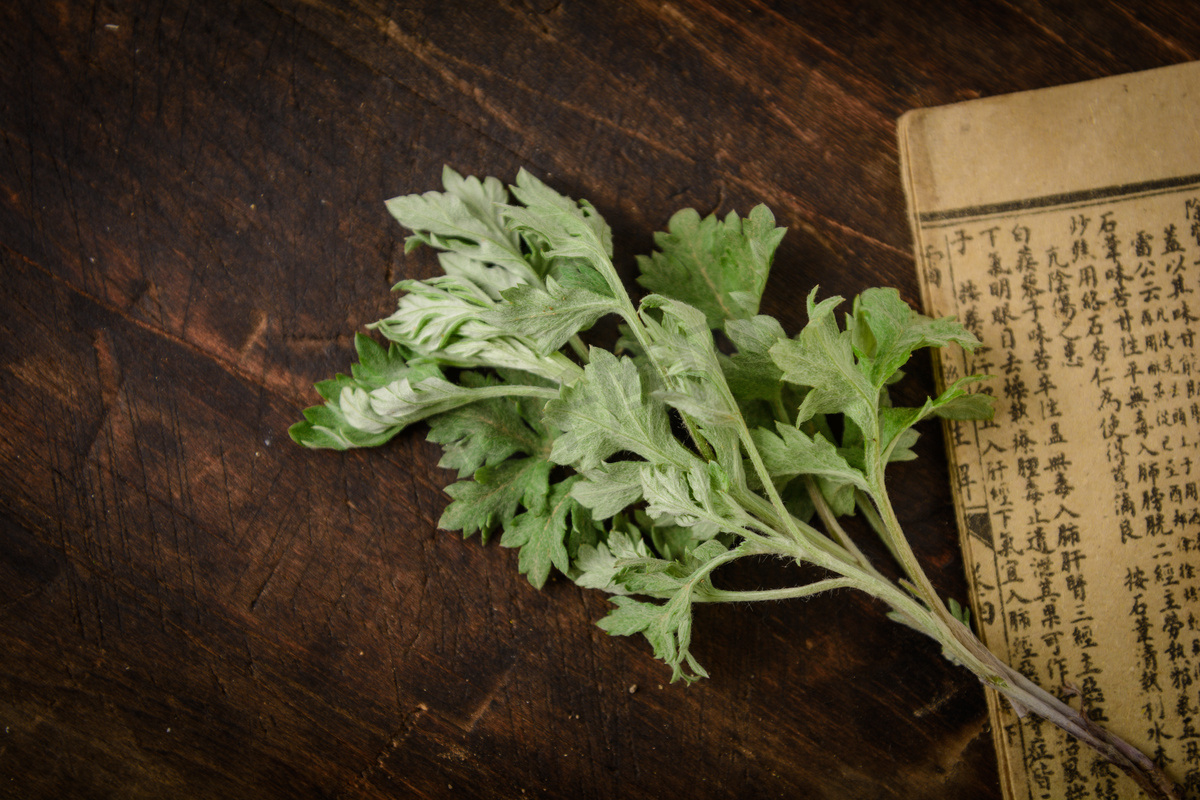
[438, 456, 551, 541]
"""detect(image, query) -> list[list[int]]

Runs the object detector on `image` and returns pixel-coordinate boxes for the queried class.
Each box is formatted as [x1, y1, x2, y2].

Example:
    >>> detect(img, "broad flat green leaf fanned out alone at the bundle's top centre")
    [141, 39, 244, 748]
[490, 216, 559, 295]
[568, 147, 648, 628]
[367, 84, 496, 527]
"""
[637, 205, 786, 327]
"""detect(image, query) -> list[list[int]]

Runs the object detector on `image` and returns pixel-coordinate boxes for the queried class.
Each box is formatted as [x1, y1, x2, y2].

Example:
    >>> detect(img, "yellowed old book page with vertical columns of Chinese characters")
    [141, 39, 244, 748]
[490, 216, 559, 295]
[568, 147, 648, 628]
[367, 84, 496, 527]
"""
[900, 64, 1200, 800]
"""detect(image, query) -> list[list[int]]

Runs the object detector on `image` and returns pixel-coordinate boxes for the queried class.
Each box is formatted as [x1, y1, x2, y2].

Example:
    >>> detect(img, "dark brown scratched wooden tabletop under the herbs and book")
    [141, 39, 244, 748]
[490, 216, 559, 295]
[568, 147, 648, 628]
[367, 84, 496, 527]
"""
[0, 0, 1200, 799]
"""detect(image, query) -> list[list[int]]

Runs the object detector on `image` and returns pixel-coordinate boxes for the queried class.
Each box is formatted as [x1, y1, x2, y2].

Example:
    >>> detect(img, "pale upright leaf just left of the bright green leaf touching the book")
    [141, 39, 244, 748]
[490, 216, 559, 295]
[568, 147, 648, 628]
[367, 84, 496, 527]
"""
[770, 289, 878, 429]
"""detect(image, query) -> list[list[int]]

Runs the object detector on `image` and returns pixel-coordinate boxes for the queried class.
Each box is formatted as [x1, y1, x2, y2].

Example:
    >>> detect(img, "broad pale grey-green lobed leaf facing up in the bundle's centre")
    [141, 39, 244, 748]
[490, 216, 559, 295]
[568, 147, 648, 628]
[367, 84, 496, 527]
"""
[545, 348, 692, 471]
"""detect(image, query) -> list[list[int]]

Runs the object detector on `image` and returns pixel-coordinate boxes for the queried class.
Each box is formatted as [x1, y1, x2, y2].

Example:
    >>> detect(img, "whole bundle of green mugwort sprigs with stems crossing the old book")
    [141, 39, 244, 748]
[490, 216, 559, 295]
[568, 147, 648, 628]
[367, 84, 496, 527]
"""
[290, 168, 1181, 798]
